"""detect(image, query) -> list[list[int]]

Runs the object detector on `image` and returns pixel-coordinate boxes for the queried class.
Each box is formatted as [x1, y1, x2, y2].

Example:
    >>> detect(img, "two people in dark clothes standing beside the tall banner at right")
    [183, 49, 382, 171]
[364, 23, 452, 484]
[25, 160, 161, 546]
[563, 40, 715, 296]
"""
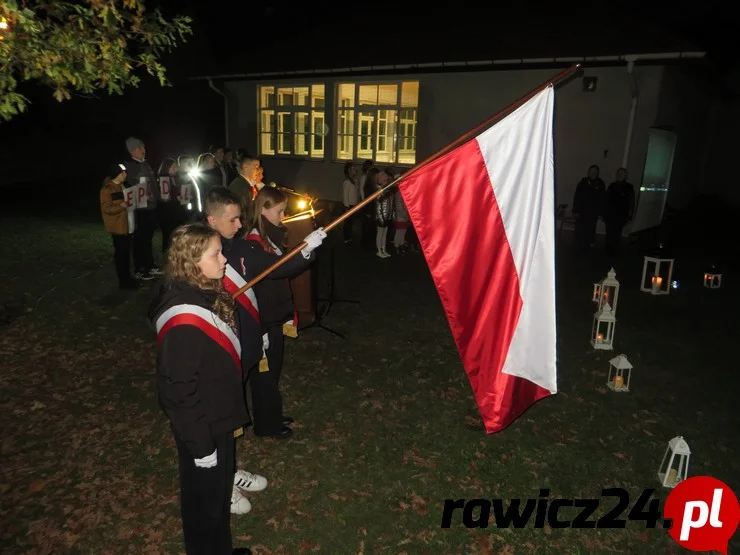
[572, 165, 635, 256]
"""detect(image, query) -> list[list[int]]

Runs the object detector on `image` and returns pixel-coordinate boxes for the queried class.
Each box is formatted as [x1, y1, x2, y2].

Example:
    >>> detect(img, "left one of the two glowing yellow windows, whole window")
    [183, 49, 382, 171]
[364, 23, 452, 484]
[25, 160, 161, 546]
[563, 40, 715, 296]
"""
[258, 85, 326, 159]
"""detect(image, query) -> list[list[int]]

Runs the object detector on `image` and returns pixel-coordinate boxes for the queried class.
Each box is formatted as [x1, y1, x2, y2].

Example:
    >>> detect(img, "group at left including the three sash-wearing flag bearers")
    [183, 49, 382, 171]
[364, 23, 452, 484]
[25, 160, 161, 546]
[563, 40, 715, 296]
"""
[101, 139, 326, 555]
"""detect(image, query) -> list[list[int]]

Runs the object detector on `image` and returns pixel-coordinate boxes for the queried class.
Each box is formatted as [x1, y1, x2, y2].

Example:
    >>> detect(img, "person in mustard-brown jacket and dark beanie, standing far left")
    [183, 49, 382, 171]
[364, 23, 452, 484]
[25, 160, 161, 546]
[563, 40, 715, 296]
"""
[100, 164, 141, 289]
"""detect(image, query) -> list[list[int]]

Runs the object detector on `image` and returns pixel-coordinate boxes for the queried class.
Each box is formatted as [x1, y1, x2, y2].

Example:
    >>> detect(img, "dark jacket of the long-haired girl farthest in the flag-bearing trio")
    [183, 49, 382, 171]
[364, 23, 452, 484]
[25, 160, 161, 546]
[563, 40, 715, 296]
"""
[245, 218, 316, 332]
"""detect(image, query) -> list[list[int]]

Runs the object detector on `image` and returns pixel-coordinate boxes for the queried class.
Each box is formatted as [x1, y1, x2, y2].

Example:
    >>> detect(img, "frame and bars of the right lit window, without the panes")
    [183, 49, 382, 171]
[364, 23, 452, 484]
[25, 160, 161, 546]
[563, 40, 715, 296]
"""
[332, 79, 421, 168]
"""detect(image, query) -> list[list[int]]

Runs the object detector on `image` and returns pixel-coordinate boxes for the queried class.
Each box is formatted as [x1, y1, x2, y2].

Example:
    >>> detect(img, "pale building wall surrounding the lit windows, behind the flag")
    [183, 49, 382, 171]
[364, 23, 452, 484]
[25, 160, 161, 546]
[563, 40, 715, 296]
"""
[225, 66, 663, 205]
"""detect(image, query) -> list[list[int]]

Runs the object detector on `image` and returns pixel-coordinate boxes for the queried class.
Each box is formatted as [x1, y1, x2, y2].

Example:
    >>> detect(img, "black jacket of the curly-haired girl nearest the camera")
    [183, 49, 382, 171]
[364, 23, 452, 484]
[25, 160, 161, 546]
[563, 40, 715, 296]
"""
[148, 281, 249, 459]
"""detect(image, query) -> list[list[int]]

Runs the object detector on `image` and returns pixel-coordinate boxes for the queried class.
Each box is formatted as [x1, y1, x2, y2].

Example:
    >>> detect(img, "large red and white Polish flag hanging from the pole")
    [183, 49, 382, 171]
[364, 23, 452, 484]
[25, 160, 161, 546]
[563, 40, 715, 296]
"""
[399, 86, 557, 433]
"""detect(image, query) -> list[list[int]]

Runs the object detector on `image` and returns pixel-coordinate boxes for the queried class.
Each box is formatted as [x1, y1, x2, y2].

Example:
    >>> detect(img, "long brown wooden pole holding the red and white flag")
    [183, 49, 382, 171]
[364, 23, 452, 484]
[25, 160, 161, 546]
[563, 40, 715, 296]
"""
[232, 64, 581, 299]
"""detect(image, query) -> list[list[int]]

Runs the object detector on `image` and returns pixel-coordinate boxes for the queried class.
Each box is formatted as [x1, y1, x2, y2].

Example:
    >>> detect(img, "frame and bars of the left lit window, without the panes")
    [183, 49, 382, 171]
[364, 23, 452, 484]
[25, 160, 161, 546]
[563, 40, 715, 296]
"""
[256, 81, 330, 162]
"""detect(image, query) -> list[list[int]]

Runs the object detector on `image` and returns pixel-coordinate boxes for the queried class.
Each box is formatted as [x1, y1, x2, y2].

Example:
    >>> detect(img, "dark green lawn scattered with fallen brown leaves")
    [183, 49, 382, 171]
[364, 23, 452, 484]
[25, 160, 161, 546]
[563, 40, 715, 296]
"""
[0, 219, 740, 554]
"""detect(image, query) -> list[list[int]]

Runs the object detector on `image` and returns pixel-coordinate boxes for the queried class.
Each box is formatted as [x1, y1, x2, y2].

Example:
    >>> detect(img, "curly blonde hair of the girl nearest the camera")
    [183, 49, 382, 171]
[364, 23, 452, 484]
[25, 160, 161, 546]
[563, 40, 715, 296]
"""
[166, 223, 236, 331]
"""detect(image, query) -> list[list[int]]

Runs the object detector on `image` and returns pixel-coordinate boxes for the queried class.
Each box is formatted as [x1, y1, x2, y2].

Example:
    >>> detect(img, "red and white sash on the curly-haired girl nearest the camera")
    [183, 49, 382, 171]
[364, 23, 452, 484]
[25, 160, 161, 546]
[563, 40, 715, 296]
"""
[156, 304, 242, 372]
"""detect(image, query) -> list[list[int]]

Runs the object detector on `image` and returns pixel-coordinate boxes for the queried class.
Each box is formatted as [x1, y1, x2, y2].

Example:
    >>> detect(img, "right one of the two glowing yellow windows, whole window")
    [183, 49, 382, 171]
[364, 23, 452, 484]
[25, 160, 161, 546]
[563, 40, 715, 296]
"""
[336, 81, 419, 165]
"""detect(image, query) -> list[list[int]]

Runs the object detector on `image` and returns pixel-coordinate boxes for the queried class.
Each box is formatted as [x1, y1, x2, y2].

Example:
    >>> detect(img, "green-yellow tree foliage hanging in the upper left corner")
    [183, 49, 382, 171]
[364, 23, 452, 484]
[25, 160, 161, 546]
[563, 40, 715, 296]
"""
[0, 0, 192, 120]
